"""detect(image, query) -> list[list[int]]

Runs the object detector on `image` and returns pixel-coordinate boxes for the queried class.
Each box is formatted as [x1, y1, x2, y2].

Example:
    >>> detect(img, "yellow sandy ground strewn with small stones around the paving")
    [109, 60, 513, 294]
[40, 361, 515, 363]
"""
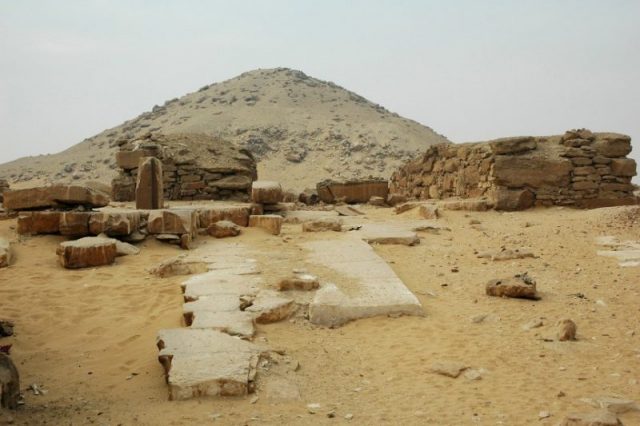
[0, 207, 640, 425]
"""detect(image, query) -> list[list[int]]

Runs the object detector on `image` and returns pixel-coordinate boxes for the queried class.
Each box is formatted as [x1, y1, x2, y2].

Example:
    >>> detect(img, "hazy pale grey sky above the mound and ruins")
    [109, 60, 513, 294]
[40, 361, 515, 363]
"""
[0, 0, 640, 175]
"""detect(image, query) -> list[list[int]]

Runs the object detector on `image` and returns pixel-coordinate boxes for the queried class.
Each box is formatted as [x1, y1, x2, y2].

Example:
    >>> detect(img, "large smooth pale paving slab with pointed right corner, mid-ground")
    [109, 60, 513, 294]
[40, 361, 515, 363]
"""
[302, 236, 424, 326]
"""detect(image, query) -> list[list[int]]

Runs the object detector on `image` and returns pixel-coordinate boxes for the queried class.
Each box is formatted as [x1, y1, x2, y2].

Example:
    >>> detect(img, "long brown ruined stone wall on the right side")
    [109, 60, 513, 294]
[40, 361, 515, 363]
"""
[390, 129, 637, 210]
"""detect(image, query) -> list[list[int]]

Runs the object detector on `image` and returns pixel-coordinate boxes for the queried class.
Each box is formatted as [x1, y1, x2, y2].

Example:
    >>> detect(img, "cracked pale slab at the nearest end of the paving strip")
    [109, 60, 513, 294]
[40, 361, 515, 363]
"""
[157, 328, 265, 400]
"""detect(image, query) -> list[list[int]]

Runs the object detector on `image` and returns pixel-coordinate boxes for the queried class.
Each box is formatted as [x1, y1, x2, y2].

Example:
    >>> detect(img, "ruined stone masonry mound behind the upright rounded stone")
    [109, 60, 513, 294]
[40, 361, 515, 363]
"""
[111, 133, 257, 203]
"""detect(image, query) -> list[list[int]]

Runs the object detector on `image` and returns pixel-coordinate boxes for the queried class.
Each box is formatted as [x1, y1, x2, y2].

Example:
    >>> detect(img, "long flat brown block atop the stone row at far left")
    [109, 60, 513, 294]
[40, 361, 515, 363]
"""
[3, 185, 110, 210]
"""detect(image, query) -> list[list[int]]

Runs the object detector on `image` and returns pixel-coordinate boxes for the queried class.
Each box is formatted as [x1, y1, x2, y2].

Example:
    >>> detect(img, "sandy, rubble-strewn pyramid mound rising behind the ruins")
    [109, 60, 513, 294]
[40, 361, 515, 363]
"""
[0, 68, 447, 190]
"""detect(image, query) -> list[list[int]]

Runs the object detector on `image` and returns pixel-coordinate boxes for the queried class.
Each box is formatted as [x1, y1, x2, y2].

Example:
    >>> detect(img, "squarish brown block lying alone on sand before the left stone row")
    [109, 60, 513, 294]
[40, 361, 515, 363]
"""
[57, 237, 117, 269]
